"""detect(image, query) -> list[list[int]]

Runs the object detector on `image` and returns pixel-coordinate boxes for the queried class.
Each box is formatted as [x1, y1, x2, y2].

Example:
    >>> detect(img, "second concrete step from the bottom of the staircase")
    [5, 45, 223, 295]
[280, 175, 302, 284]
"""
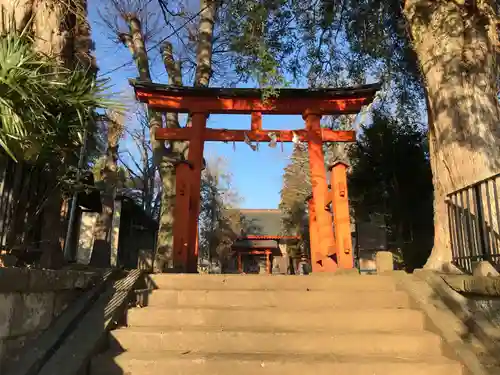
[111, 327, 441, 358]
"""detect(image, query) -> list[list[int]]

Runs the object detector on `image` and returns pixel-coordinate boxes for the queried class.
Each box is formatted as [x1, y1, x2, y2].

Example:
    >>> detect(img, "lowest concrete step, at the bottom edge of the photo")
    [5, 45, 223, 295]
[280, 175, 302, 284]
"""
[91, 352, 463, 375]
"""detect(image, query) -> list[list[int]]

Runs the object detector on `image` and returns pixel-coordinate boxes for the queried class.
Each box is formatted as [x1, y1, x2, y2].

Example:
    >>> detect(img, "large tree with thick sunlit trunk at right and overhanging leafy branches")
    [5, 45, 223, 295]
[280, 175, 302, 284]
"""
[223, 0, 500, 269]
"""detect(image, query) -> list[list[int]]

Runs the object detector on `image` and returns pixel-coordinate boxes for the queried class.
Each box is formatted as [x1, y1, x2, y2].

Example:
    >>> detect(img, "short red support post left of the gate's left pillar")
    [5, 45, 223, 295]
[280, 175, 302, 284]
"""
[174, 163, 191, 272]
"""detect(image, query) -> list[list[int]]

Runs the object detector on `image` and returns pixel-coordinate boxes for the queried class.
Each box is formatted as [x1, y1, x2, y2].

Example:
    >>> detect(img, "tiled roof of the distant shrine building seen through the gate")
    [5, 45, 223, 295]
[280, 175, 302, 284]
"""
[229, 209, 281, 237]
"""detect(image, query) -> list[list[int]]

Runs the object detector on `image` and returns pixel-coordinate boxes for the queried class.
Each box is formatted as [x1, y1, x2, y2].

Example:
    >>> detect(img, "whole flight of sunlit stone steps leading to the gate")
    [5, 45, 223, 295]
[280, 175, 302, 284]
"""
[90, 274, 465, 375]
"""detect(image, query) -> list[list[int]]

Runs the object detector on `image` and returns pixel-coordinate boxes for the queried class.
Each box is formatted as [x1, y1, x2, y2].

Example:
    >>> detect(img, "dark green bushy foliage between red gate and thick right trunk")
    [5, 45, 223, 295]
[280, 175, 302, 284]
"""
[349, 112, 433, 269]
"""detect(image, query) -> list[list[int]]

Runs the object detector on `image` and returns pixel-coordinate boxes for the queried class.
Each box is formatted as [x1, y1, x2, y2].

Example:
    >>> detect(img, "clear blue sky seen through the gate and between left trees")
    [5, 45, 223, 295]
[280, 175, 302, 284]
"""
[89, 2, 304, 208]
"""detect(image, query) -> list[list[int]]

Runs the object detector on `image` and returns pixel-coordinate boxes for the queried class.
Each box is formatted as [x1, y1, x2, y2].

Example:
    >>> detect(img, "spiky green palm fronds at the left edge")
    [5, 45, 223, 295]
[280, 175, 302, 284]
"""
[0, 32, 119, 161]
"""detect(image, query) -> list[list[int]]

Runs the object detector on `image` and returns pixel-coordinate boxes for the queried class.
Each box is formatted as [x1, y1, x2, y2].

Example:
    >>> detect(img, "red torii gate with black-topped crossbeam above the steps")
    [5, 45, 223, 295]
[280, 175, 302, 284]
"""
[131, 80, 380, 272]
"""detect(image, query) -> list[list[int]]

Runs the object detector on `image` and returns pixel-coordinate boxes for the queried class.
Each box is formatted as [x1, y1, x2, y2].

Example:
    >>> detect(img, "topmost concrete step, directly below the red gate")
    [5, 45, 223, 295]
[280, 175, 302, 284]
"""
[150, 274, 396, 292]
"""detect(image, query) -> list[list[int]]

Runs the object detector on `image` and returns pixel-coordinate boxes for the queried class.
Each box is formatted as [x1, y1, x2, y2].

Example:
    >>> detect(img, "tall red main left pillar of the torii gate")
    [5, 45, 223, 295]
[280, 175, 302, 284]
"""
[187, 112, 207, 273]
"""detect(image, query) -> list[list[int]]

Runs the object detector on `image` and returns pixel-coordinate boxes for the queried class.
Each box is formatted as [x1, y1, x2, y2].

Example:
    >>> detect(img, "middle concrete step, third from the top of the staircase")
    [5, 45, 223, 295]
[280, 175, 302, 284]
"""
[127, 307, 426, 332]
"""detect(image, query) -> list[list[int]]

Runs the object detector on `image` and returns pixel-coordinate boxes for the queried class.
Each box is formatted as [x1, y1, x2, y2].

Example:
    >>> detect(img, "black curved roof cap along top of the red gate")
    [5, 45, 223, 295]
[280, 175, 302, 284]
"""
[129, 79, 381, 100]
